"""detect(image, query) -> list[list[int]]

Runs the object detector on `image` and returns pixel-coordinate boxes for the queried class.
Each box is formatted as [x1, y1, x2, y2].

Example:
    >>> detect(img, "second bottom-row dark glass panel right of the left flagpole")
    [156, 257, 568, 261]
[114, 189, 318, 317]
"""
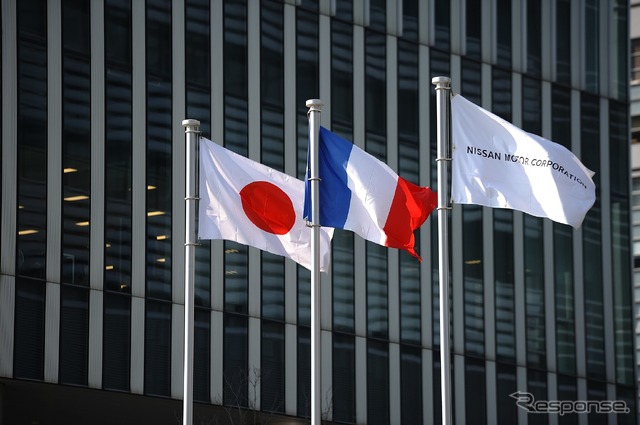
[222, 313, 250, 407]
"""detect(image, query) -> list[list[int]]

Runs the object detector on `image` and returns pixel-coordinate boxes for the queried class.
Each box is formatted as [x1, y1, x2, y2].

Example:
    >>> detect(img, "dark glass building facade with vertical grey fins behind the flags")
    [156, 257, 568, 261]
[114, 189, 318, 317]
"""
[0, 0, 639, 425]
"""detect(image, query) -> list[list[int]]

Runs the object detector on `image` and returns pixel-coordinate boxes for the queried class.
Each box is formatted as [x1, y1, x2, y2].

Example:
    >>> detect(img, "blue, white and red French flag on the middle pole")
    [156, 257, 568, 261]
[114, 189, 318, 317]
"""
[303, 127, 438, 261]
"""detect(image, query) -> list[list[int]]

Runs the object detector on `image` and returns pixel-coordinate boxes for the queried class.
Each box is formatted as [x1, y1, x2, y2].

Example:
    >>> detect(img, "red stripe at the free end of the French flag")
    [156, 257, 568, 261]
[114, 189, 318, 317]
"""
[383, 177, 438, 261]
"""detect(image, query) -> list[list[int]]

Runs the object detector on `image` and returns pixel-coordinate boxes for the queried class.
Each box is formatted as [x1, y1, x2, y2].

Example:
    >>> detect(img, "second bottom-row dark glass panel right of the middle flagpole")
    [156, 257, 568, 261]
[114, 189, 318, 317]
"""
[367, 339, 389, 425]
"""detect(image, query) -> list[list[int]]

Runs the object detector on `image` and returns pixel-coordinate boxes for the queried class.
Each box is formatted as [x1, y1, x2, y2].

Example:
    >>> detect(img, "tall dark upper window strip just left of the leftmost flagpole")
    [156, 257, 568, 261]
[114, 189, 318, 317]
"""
[146, 0, 173, 300]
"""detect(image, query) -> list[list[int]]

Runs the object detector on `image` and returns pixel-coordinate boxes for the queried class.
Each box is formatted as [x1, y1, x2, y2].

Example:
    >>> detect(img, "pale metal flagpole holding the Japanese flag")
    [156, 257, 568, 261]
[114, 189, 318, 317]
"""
[182, 120, 200, 425]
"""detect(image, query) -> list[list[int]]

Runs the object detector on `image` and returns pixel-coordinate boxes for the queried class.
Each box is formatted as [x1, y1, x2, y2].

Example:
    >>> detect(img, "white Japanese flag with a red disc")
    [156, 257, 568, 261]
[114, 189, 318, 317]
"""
[198, 138, 333, 271]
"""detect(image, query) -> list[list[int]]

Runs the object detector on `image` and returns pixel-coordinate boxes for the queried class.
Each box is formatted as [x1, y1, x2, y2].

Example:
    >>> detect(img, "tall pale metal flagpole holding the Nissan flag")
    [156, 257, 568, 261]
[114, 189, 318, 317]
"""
[431, 77, 452, 425]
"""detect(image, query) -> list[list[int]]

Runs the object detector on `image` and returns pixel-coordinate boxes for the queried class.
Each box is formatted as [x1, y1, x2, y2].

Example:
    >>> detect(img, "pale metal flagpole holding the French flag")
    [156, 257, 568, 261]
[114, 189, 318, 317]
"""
[306, 99, 323, 425]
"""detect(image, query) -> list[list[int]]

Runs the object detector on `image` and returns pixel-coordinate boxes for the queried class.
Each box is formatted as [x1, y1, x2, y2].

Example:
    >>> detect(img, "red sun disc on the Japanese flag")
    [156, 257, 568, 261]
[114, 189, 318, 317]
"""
[240, 181, 296, 235]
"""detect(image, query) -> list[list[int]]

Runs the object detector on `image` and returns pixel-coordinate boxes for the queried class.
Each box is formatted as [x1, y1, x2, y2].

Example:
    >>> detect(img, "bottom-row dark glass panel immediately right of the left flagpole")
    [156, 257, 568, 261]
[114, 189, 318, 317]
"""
[193, 308, 211, 403]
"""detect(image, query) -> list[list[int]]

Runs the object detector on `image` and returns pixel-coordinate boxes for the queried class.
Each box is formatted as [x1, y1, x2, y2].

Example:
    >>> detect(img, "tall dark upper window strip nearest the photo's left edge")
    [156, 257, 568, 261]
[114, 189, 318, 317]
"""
[16, 0, 47, 279]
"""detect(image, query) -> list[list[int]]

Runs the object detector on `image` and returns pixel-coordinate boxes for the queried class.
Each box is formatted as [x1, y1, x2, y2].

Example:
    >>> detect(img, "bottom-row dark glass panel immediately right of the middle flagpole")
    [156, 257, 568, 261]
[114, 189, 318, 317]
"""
[331, 332, 356, 423]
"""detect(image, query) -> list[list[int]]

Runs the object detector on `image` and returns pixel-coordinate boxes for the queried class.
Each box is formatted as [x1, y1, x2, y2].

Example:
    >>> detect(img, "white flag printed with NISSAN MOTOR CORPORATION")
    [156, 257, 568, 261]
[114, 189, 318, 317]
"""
[451, 95, 596, 229]
